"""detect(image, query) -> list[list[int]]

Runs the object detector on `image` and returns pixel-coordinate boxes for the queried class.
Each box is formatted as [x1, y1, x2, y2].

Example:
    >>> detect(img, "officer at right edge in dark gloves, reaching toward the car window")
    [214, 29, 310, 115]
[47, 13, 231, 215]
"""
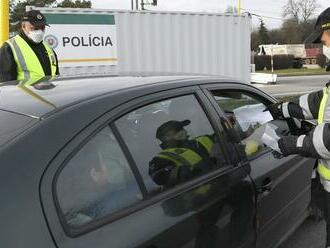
[268, 8, 330, 248]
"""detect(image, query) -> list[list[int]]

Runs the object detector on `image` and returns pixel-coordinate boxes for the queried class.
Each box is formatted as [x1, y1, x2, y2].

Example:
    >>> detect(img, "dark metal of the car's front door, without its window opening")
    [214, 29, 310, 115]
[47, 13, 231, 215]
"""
[203, 84, 315, 247]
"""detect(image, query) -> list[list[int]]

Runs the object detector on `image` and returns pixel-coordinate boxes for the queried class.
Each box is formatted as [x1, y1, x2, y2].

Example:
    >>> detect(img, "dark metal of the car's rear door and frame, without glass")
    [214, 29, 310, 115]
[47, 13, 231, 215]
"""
[42, 87, 255, 248]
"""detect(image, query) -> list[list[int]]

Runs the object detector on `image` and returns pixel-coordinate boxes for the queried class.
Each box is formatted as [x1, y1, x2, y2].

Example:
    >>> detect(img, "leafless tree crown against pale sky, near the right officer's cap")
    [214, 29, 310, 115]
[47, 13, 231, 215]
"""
[283, 0, 319, 23]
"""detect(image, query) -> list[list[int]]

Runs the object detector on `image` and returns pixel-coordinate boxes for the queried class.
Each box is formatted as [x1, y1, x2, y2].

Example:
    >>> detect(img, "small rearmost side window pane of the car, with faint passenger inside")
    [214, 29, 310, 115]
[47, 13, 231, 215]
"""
[56, 127, 142, 227]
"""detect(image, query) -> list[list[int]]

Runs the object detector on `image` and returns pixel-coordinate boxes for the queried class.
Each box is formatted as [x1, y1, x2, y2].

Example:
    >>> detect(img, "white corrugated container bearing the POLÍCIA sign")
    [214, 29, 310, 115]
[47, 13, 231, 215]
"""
[27, 6, 251, 82]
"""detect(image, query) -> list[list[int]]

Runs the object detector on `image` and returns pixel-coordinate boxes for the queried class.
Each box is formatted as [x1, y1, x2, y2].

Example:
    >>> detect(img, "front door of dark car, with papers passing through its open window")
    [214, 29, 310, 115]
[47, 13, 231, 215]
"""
[205, 84, 314, 247]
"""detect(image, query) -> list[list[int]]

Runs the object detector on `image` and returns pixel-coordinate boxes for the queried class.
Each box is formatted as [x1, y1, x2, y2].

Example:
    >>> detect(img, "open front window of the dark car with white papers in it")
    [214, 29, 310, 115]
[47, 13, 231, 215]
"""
[211, 90, 273, 156]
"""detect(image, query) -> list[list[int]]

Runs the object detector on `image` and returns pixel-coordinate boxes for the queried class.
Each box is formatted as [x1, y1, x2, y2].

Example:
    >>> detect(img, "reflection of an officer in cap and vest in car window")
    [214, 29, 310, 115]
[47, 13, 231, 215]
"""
[149, 120, 215, 187]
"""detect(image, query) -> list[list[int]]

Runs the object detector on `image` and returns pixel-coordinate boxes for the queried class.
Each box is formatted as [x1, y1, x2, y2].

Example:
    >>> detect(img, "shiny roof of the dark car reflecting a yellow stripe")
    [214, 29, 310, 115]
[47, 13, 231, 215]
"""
[0, 75, 237, 119]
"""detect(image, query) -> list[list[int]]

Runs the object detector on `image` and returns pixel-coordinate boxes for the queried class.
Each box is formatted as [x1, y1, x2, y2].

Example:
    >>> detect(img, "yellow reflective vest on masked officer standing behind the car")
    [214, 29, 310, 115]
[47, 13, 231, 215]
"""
[6, 35, 56, 81]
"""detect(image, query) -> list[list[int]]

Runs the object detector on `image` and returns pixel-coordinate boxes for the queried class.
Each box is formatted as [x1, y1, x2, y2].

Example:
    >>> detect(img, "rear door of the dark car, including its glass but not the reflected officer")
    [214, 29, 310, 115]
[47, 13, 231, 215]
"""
[41, 87, 255, 248]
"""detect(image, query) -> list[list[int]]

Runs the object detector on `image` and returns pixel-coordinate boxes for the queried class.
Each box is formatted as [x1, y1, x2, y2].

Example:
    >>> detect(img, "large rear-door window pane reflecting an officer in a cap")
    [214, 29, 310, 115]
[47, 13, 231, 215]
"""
[115, 95, 231, 194]
